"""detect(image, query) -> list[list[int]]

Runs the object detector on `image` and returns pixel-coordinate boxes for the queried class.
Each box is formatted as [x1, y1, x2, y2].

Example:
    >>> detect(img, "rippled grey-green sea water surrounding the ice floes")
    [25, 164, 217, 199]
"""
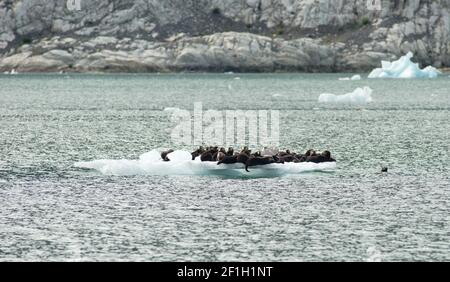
[0, 74, 450, 261]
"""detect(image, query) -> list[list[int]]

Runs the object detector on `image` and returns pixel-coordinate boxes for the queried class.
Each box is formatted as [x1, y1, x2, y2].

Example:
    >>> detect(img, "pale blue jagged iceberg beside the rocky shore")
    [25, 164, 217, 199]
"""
[369, 52, 441, 78]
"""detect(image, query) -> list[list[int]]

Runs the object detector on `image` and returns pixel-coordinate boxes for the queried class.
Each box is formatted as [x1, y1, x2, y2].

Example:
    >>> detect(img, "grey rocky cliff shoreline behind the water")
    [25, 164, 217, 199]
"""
[0, 0, 450, 72]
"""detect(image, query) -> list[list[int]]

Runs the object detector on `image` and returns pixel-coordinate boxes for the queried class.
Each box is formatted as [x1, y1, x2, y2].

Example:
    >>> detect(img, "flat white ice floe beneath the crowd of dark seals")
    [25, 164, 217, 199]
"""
[74, 150, 336, 177]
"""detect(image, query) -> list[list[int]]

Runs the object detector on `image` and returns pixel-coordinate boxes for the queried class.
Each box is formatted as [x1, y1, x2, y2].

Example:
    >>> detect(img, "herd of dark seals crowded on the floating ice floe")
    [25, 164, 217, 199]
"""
[161, 146, 336, 172]
